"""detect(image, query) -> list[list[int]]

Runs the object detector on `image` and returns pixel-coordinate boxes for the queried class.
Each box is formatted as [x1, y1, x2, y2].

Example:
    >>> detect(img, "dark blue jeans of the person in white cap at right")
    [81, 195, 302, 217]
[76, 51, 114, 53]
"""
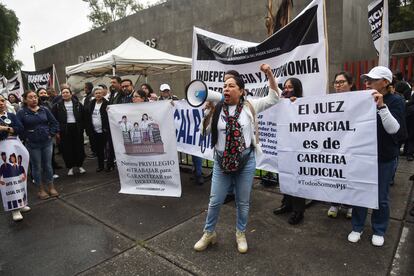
[352, 158, 397, 236]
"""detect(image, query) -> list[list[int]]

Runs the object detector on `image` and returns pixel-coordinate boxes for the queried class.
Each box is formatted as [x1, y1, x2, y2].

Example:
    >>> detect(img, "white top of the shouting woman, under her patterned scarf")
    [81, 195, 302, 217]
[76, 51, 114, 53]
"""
[215, 105, 253, 151]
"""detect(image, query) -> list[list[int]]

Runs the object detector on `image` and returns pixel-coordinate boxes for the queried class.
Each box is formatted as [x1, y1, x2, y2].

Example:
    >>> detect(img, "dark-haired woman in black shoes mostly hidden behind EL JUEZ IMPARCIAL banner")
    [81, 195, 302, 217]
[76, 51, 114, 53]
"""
[273, 78, 305, 225]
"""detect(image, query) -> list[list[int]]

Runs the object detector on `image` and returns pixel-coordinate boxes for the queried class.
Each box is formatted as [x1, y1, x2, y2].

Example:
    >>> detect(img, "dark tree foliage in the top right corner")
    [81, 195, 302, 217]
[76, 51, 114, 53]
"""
[388, 0, 414, 33]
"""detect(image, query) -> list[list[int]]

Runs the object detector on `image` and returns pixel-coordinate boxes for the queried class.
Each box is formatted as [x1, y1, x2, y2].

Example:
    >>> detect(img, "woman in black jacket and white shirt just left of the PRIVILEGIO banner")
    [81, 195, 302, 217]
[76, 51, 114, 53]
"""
[86, 86, 110, 172]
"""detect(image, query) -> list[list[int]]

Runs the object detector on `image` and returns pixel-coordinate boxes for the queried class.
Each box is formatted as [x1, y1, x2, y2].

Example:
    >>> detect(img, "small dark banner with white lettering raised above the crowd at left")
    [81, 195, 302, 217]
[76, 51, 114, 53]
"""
[21, 66, 55, 91]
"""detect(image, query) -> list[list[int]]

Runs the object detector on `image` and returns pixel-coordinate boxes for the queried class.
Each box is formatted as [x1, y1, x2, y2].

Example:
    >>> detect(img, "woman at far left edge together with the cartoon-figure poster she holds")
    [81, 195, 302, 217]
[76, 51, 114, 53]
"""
[0, 95, 30, 221]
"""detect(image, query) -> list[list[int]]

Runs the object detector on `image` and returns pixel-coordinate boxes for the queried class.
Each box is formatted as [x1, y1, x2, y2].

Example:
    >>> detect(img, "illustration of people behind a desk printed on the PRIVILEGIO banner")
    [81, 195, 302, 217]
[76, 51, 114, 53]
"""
[119, 113, 164, 155]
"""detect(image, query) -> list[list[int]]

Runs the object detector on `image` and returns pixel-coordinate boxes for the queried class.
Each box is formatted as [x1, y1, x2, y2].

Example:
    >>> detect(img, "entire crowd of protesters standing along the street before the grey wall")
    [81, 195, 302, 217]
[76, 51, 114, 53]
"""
[0, 64, 414, 253]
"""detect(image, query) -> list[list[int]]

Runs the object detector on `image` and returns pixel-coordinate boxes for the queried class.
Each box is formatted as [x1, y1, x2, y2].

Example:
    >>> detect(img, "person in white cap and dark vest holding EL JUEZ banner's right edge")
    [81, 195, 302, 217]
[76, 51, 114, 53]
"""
[348, 66, 406, 246]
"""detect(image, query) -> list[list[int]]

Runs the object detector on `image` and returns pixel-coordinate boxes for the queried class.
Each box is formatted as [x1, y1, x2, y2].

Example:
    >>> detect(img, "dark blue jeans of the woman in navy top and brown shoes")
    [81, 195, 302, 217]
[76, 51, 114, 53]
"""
[26, 139, 53, 185]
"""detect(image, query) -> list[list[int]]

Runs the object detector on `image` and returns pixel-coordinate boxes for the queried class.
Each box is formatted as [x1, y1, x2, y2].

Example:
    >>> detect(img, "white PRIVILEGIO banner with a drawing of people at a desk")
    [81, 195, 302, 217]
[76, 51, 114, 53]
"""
[108, 101, 181, 197]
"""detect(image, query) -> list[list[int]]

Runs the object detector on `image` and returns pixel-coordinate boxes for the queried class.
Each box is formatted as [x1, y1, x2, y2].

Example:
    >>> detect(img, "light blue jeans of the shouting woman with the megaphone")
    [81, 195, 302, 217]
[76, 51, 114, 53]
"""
[204, 149, 256, 232]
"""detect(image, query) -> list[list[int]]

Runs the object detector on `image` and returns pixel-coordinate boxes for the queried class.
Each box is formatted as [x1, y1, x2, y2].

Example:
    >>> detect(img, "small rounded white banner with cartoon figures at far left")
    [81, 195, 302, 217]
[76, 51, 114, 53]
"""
[0, 137, 29, 211]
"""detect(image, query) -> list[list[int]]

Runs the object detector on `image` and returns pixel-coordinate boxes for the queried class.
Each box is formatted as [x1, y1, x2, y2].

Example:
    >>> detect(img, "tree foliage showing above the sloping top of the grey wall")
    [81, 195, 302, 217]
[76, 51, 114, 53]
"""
[82, 0, 144, 28]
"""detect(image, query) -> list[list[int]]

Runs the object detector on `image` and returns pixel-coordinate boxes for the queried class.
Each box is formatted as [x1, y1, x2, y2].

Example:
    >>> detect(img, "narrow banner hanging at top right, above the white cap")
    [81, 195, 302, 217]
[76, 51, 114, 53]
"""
[368, 0, 389, 67]
